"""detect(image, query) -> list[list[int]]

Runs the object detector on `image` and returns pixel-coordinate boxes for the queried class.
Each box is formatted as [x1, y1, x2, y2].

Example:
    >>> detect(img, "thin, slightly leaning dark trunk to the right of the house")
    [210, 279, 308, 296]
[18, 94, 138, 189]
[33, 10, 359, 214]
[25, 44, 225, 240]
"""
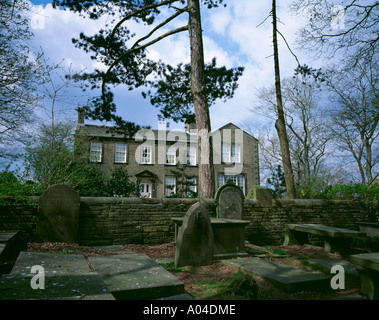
[272, 0, 296, 199]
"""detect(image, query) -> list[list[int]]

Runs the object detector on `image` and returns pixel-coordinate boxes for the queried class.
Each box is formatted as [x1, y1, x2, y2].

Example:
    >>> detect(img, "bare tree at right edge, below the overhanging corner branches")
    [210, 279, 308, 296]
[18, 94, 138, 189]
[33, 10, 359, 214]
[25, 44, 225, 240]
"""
[328, 61, 379, 184]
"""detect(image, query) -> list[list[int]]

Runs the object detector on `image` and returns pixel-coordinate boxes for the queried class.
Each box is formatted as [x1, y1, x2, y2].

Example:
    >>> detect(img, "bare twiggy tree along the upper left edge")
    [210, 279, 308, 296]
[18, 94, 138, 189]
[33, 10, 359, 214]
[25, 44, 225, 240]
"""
[0, 0, 43, 160]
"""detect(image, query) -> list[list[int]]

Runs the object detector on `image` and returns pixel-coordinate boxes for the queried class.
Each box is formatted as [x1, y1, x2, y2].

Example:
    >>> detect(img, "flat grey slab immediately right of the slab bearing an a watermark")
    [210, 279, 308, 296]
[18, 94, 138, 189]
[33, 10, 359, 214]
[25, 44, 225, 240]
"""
[88, 254, 185, 300]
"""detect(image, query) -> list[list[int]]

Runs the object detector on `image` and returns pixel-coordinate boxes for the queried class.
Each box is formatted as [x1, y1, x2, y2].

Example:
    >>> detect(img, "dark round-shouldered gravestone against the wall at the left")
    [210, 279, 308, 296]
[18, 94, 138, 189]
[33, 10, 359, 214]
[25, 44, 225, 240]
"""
[36, 184, 80, 242]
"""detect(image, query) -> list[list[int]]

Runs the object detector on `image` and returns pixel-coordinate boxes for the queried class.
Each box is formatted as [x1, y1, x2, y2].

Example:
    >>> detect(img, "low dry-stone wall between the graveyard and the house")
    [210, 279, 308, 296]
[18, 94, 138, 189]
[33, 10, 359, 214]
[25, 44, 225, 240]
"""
[0, 197, 374, 245]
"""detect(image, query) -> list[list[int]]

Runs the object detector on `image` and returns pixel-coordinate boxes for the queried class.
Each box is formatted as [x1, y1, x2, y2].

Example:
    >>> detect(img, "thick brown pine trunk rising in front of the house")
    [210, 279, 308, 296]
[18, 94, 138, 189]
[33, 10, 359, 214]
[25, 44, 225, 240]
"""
[188, 0, 215, 198]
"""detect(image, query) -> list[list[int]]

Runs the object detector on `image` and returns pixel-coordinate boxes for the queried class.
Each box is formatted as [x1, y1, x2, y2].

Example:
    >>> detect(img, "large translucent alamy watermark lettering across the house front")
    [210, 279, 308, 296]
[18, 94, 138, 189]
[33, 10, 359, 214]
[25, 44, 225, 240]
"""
[135, 122, 244, 175]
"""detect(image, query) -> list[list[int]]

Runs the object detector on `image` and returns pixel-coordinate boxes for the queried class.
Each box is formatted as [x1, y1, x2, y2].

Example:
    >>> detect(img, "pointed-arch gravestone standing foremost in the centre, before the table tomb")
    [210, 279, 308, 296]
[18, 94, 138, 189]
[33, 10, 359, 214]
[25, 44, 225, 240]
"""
[175, 202, 214, 267]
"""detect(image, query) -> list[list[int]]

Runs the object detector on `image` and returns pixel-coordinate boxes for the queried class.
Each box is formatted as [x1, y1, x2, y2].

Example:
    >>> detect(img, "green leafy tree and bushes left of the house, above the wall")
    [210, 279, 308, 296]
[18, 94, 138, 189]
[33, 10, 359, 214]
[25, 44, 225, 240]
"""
[25, 123, 105, 197]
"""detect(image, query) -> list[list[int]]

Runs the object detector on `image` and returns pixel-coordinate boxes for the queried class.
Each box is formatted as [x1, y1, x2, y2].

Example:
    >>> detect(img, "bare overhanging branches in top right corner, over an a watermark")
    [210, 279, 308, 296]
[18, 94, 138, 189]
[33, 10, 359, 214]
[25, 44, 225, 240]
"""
[291, 0, 379, 65]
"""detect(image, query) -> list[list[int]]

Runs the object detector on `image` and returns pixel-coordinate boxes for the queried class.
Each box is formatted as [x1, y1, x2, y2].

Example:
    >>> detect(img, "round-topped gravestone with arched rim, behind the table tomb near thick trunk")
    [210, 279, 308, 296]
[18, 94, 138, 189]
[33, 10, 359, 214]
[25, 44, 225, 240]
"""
[215, 183, 244, 220]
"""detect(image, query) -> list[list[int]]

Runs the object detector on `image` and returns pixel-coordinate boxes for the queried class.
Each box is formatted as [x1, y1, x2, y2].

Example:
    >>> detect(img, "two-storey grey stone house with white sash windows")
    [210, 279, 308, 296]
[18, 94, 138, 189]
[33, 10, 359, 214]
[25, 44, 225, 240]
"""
[75, 110, 259, 198]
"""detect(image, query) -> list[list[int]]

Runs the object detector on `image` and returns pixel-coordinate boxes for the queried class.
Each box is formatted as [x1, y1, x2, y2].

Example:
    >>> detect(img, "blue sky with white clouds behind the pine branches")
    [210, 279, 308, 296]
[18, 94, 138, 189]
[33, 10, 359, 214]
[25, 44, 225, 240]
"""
[25, 0, 315, 130]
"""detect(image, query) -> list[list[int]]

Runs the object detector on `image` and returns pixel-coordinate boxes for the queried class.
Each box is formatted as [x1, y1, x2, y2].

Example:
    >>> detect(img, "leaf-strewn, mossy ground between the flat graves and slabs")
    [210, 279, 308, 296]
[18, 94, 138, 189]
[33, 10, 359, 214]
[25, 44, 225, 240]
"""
[28, 242, 360, 300]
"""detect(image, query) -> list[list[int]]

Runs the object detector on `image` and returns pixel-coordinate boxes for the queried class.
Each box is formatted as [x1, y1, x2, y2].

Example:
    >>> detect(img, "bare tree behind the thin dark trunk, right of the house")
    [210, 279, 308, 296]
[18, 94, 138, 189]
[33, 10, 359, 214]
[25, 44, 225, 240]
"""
[250, 77, 332, 191]
